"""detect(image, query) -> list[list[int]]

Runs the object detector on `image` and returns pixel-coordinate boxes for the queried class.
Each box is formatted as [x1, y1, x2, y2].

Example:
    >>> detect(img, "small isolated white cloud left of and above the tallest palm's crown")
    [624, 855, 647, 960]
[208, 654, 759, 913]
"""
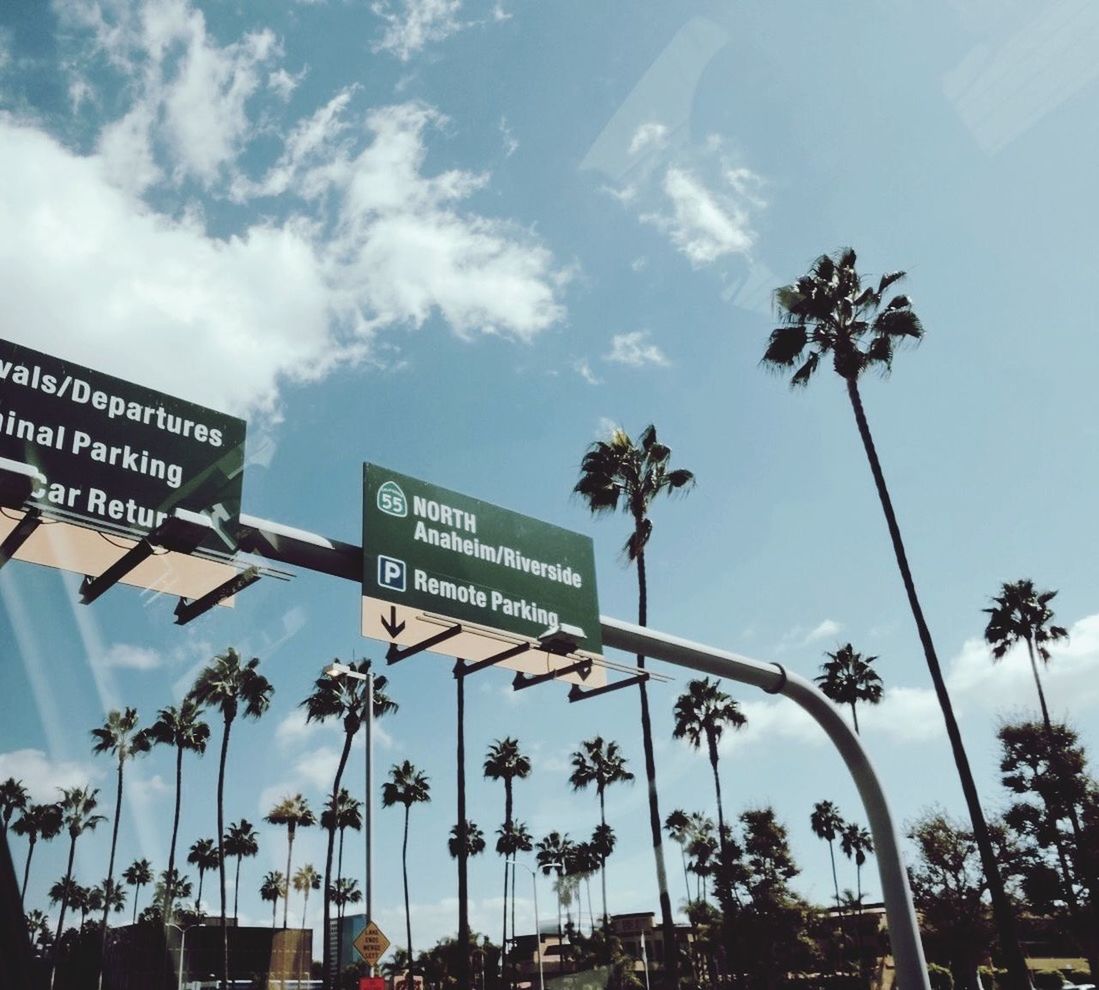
[641, 167, 755, 265]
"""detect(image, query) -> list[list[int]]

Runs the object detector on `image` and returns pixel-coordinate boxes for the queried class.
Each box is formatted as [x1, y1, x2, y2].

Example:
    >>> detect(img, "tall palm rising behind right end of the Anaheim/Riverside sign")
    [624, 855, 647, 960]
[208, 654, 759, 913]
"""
[573, 425, 695, 987]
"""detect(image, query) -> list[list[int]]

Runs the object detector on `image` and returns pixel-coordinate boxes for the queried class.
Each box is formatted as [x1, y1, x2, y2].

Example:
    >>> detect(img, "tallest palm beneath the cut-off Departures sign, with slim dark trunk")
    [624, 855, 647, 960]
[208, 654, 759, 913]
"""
[189, 646, 275, 987]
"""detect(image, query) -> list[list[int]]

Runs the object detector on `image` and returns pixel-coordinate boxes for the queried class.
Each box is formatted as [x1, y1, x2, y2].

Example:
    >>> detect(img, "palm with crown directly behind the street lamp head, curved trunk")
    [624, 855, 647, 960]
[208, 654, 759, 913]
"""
[303, 660, 399, 972]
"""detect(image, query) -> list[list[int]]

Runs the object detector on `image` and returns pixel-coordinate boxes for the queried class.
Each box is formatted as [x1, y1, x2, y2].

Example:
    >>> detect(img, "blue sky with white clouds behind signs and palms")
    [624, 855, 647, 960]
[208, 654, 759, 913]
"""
[0, 0, 1099, 946]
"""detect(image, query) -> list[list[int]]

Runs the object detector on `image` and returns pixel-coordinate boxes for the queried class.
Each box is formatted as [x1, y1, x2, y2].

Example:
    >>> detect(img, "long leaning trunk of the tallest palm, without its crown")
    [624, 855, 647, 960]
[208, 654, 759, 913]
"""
[846, 378, 1031, 990]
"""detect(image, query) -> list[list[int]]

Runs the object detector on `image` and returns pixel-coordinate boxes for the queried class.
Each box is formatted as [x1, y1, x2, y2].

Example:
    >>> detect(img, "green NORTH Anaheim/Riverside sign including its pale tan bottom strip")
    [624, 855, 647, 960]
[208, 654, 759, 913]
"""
[363, 464, 606, 687]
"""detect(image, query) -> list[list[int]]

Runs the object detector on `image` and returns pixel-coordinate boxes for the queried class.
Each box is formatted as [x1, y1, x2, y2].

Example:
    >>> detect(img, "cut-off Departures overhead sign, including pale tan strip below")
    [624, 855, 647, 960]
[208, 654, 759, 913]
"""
[0, 341, 263, 601]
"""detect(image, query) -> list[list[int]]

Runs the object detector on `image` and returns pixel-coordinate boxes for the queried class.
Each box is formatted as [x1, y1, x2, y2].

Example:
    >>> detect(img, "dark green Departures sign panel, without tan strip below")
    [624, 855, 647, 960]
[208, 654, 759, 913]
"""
[0, 341, 245, 555]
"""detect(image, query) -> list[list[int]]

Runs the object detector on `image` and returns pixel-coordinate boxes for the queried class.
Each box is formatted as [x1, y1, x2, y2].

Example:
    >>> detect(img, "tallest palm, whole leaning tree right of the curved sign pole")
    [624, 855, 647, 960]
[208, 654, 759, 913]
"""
[762, 247, 1030, 990]
